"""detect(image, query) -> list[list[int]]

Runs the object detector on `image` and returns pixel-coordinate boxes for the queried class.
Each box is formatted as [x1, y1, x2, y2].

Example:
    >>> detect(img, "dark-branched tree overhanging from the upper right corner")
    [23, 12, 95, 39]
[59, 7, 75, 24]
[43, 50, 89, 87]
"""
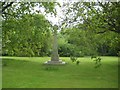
[60, 2, 120, 55]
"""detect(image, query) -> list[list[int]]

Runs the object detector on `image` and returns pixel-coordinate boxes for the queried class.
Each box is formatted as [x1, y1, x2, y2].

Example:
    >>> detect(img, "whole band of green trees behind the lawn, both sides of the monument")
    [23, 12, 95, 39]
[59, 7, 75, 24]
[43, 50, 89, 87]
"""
[1, 2, 120, 56]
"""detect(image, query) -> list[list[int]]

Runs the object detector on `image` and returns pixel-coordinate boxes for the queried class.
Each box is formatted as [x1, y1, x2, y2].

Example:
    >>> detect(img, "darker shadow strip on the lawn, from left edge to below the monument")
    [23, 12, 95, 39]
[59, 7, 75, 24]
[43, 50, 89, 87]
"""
[2, 58, 62, 71]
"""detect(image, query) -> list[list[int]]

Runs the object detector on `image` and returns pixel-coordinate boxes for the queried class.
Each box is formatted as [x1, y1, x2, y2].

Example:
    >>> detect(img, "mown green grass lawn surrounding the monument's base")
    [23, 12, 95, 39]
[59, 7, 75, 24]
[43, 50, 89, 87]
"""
[2, 57, 118, 88]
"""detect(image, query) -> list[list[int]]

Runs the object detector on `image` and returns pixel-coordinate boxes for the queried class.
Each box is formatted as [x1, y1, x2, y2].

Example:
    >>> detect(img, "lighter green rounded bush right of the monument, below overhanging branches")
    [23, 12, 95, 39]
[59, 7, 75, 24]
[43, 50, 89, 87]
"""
[61, 27, 97, 56]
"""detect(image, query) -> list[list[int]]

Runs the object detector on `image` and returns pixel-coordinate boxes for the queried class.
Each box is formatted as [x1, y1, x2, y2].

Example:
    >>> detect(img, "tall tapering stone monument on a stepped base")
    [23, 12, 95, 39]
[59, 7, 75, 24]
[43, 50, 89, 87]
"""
[45, 26, 65, 65]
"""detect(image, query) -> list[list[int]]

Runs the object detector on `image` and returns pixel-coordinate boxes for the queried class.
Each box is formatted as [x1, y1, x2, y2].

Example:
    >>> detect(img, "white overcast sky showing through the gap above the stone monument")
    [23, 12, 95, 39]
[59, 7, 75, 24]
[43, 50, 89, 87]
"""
[35, 0, 114, 25]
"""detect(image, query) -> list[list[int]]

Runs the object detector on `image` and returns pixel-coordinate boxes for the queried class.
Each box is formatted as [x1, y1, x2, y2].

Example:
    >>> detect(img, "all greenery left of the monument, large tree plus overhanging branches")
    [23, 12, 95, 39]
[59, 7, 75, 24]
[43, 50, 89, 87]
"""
[1, 2, 58, 56]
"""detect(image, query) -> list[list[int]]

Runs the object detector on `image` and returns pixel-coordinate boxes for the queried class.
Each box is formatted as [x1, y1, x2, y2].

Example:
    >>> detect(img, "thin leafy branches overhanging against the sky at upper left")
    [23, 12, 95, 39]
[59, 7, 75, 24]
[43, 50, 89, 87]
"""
[1, 1, 58, 19]
